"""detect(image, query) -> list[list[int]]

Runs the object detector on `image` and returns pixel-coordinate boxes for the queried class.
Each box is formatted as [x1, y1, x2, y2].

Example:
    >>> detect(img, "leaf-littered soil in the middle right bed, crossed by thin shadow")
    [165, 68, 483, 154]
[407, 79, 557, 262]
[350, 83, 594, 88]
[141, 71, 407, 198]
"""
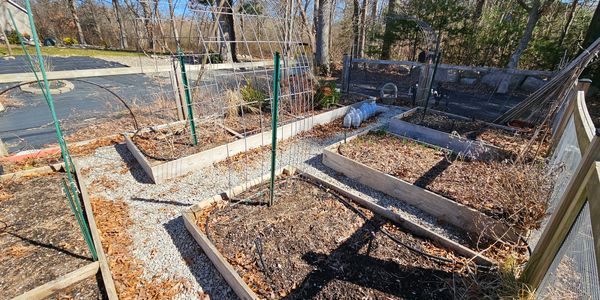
[338, 131, 552, 229]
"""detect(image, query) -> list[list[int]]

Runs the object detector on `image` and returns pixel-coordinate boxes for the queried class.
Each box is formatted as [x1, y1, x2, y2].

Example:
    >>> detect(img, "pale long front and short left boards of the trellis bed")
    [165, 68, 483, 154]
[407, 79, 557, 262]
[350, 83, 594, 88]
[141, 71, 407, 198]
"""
[125, 101, 365, 183]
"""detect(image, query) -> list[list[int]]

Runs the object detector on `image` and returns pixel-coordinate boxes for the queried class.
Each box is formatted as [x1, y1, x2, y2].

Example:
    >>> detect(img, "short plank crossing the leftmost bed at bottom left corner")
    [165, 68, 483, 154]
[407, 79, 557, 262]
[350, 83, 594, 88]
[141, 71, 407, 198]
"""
[13, 261, 100, 300]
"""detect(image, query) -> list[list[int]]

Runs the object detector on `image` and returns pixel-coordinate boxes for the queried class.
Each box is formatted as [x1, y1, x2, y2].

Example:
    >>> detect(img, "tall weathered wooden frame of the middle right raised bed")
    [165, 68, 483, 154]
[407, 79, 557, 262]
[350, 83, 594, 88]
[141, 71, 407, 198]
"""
[323, 131, 519, 242]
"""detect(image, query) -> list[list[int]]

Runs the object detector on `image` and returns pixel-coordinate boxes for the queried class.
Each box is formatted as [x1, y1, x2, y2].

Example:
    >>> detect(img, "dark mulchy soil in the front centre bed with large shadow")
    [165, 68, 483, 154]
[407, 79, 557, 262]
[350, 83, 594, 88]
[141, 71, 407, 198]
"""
[196, 178, 460, 299]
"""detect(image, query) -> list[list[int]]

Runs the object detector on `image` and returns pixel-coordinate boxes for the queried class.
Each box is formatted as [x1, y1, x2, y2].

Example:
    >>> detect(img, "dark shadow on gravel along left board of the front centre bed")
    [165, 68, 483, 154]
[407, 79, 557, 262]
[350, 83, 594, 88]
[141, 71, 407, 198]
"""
[163, 216, 237, 299]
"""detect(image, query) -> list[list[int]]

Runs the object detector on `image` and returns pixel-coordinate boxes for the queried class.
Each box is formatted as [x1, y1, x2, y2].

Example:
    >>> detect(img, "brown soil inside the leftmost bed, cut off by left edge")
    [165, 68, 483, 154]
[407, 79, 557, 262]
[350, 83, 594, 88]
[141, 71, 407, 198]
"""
[0, 173, 101, 299]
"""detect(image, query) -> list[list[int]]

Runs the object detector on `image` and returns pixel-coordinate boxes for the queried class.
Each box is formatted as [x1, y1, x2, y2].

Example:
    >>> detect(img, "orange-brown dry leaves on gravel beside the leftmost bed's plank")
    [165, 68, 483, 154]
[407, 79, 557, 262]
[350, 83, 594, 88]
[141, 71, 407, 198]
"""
[91, 197, 188, 299]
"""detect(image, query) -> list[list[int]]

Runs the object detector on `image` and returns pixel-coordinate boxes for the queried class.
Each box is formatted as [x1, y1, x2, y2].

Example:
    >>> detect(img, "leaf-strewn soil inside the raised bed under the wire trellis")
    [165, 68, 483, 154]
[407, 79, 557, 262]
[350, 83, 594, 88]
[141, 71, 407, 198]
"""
[132, 123, 237, 162]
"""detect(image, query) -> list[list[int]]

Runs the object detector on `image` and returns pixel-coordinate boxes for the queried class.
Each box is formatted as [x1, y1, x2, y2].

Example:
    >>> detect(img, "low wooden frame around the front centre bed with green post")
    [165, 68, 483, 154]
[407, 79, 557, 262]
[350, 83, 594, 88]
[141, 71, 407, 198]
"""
[182, 167, 496, 299]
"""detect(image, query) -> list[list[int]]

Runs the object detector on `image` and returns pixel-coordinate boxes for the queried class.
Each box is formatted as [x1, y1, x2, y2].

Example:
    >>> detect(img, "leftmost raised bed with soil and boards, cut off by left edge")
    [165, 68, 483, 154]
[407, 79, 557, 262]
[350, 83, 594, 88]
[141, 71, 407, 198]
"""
[0, 168, 116, 299]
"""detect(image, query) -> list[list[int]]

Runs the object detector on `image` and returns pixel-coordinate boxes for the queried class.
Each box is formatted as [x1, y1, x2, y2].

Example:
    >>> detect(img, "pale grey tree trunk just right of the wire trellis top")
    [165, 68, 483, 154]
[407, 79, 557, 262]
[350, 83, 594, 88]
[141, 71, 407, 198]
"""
[315, 0, 333, 76]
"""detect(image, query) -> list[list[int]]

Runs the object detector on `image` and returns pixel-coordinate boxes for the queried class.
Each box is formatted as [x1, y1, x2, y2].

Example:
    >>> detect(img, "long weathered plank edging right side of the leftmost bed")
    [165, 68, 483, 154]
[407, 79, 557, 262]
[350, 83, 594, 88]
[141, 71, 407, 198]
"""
[73, 162, 119, 300]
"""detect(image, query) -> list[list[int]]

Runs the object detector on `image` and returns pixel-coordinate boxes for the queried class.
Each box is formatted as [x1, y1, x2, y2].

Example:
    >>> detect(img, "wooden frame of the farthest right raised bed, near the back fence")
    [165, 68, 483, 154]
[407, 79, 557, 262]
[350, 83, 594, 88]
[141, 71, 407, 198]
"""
[388, 107, 515, 160]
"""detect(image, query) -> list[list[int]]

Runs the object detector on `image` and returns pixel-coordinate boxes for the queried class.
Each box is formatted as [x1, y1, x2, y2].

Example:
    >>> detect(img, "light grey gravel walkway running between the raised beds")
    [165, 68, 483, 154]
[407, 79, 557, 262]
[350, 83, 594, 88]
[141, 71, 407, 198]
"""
[77, 108, 468, 299]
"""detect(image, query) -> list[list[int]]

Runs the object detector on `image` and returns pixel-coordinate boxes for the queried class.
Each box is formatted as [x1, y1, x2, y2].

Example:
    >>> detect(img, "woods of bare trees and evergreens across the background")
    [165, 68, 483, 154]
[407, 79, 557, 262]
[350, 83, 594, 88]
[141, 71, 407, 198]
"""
[2, 0, 598, 74]
